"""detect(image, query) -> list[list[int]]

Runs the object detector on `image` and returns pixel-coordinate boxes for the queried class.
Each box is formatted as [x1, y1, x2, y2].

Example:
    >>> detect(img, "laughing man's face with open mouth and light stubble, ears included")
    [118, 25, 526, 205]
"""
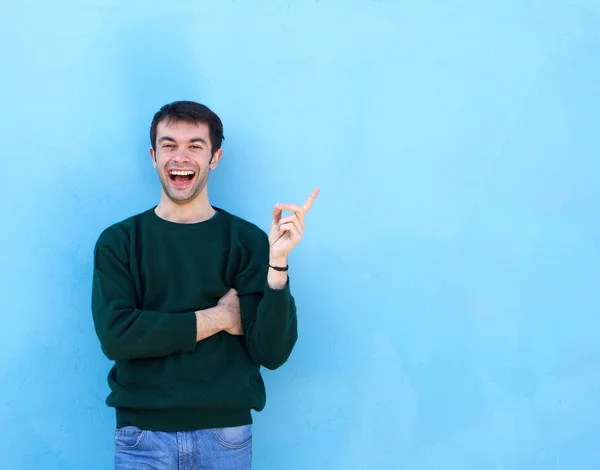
[150, 121, 222, 204]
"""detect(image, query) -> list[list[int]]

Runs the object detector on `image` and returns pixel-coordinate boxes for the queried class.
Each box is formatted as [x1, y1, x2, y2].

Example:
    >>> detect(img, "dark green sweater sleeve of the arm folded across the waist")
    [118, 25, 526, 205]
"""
[92, 232, 196, 360]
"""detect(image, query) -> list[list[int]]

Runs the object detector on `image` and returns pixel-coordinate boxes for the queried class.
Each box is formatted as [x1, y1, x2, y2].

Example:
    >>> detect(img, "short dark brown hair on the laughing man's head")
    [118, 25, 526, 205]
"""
[150, 101, 225, 154]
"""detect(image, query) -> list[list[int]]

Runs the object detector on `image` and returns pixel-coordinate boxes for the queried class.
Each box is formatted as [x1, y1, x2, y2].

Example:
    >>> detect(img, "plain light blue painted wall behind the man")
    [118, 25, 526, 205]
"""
[0, 0, 600, 470]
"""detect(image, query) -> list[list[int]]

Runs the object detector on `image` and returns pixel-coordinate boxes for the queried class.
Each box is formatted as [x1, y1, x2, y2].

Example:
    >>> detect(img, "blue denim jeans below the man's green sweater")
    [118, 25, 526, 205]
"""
[115, 425, 252, 470]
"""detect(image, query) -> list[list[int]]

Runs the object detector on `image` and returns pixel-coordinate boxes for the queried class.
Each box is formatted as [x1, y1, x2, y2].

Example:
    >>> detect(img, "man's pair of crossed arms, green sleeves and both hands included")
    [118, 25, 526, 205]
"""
[92, 190, 318, 369]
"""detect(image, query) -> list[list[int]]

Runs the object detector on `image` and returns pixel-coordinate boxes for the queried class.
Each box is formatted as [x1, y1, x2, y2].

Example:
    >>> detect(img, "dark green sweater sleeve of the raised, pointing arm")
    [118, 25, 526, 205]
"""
[236, 233, 298, 370]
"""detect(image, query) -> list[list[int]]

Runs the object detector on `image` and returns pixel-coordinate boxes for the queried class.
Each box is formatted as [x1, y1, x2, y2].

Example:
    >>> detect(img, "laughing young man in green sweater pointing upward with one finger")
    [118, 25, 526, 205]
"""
[92, 101, 319, 470]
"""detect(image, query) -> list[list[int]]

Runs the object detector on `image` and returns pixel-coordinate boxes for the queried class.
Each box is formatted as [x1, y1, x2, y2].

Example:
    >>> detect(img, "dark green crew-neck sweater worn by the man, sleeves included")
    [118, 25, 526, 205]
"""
[92, 208, 297, 431]
